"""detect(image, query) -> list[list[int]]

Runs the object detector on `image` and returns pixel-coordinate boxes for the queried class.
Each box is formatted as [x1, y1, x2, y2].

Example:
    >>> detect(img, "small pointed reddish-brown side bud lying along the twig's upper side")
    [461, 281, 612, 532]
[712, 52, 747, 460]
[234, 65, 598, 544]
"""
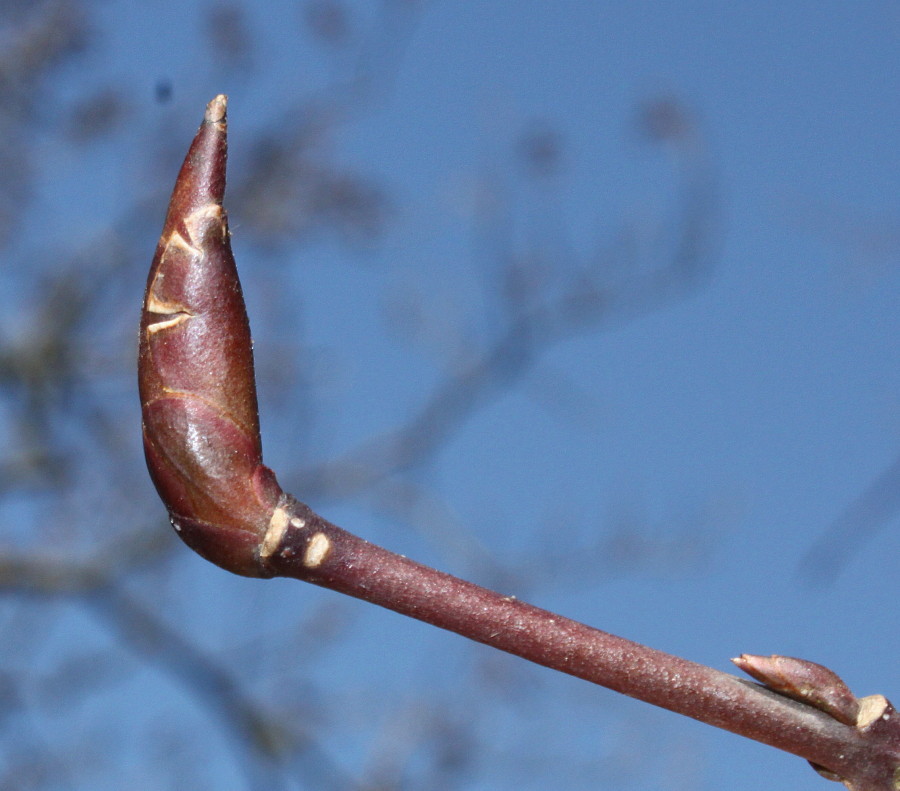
[731, 654, 859, 725]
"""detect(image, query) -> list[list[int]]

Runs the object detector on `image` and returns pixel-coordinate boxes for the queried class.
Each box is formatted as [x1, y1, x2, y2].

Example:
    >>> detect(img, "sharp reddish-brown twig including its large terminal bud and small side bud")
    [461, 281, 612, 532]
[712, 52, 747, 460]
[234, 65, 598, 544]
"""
[139, 96, 900, 791]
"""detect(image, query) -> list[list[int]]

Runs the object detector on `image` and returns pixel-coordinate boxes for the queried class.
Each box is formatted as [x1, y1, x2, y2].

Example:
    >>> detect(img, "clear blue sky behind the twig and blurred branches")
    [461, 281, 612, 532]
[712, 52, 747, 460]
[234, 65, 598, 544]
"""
[8, 0, 900, 791]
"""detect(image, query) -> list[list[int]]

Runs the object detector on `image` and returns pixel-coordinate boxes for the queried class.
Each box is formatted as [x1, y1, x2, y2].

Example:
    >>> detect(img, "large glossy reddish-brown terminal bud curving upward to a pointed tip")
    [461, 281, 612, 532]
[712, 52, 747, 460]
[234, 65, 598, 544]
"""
[138, 96, 282, 576]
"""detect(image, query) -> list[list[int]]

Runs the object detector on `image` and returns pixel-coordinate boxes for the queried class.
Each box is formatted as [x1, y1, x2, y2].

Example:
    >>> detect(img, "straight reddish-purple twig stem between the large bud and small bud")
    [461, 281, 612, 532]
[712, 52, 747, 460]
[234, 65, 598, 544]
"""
[261, 501, 896, 791]
